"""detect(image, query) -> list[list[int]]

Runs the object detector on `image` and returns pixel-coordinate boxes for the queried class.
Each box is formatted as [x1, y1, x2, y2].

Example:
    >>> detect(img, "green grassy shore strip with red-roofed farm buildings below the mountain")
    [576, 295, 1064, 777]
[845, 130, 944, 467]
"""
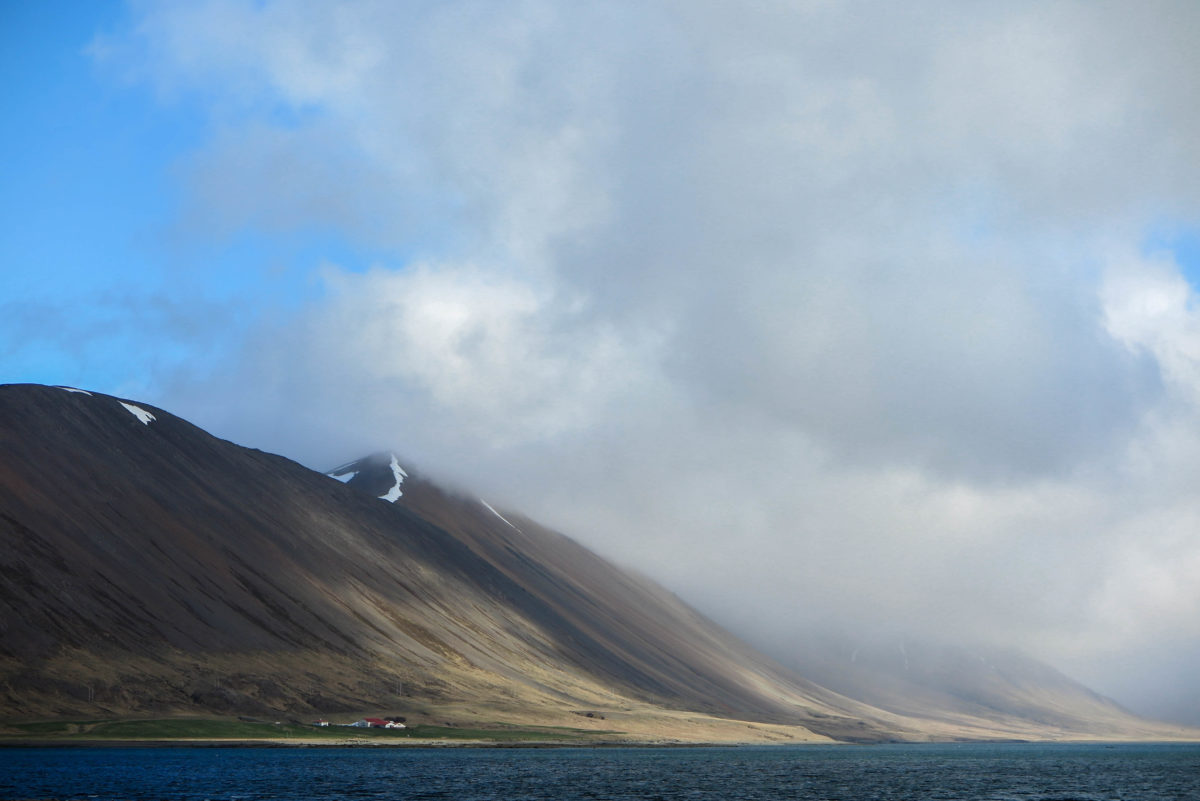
[0, 717, 609, 742]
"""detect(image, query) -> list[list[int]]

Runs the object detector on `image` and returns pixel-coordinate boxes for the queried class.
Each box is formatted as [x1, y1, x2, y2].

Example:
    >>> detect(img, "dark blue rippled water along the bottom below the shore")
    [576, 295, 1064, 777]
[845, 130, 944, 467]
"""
[0, 743, 1200, 801]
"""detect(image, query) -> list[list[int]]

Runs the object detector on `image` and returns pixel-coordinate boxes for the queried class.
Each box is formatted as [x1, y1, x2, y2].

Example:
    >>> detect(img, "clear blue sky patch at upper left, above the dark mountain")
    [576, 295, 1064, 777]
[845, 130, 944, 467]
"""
[0, 1, 388, 395]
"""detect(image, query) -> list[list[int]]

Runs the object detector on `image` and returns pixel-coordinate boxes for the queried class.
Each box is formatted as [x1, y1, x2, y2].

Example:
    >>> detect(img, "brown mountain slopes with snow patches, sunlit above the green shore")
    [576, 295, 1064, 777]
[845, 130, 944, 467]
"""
[0, 385, 1190, 741]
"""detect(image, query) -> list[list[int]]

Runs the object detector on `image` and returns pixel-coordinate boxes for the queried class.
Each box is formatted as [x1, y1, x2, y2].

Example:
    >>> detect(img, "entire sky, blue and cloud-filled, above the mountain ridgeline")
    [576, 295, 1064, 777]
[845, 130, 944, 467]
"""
[7, 0, 1200, 722]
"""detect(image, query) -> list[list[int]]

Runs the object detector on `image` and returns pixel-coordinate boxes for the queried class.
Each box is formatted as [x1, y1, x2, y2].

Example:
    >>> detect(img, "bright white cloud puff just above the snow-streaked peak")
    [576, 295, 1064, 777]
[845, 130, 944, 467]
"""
[307, 264, 667, 447]
